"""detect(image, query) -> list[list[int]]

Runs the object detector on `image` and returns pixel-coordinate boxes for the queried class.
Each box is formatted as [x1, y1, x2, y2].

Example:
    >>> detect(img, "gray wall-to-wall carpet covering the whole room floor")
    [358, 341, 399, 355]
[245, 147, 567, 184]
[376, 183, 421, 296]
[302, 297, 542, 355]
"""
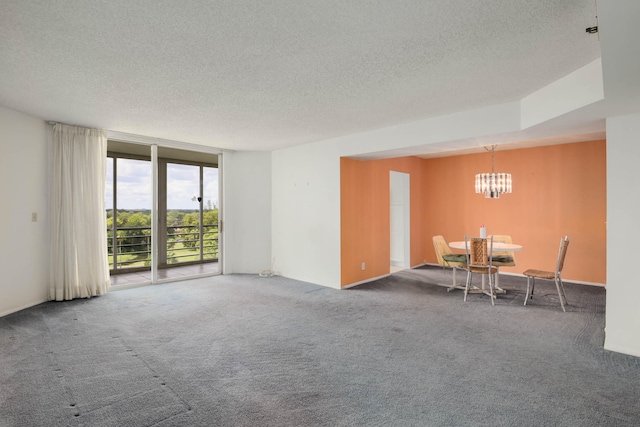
[0, 267, 640, 426]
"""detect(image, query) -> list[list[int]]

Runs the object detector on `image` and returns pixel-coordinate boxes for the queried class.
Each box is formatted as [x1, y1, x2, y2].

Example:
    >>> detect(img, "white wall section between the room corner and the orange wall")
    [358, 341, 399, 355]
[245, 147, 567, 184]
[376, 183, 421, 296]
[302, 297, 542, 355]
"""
[272, 142, 340, 288]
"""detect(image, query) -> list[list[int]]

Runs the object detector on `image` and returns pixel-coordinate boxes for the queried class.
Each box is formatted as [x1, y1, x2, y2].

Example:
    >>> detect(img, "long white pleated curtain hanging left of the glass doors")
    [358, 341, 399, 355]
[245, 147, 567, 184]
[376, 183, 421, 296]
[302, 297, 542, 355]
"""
[49, 124, 111, 301]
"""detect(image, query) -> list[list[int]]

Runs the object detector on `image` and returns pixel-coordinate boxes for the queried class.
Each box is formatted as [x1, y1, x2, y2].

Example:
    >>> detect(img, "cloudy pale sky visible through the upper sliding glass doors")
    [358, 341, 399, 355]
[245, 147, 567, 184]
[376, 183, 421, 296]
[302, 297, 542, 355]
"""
[105, 157, 219, 210]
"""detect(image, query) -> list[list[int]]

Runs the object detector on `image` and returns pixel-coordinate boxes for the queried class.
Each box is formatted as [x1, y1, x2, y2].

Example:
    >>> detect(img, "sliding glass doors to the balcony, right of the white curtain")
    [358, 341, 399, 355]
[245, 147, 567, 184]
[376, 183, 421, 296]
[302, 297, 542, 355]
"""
[106, 141, 220, 283]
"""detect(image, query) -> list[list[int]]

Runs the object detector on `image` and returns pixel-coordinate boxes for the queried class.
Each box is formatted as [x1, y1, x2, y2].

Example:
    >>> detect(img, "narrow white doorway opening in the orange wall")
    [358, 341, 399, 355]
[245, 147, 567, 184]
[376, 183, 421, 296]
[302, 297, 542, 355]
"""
[389, 171, 411, 273]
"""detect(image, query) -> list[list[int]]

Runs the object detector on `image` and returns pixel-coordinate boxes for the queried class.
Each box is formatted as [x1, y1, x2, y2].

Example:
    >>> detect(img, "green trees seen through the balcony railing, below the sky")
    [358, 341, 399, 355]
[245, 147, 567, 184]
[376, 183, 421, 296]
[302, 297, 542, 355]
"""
[106, 205, 218, 268]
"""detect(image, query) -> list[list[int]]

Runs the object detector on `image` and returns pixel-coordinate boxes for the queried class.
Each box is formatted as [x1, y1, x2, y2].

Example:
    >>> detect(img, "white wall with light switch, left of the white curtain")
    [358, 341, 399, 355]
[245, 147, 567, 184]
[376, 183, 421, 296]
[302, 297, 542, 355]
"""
[0, 107, 49, 316]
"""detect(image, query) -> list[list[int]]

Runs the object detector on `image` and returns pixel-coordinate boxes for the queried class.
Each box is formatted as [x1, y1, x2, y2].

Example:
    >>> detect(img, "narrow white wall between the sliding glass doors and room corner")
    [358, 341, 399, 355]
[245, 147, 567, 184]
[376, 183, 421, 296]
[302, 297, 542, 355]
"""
[222, 152, 272, 274]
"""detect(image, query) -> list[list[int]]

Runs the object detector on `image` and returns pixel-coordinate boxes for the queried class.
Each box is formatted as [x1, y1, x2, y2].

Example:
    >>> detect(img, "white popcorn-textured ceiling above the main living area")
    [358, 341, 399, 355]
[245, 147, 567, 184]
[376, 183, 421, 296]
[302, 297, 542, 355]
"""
[0, 0, 600, 150]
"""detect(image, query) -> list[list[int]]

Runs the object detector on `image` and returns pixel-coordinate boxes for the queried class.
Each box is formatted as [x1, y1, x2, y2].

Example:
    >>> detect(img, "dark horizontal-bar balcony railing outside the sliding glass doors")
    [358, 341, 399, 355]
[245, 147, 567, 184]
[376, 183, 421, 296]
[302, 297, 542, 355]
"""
[107, 224, 219, 270]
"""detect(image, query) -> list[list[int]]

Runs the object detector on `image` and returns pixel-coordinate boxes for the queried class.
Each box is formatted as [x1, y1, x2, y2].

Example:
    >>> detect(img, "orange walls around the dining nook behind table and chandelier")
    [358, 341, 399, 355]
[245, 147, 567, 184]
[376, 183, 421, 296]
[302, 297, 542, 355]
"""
[340, 140, 606, 286]
